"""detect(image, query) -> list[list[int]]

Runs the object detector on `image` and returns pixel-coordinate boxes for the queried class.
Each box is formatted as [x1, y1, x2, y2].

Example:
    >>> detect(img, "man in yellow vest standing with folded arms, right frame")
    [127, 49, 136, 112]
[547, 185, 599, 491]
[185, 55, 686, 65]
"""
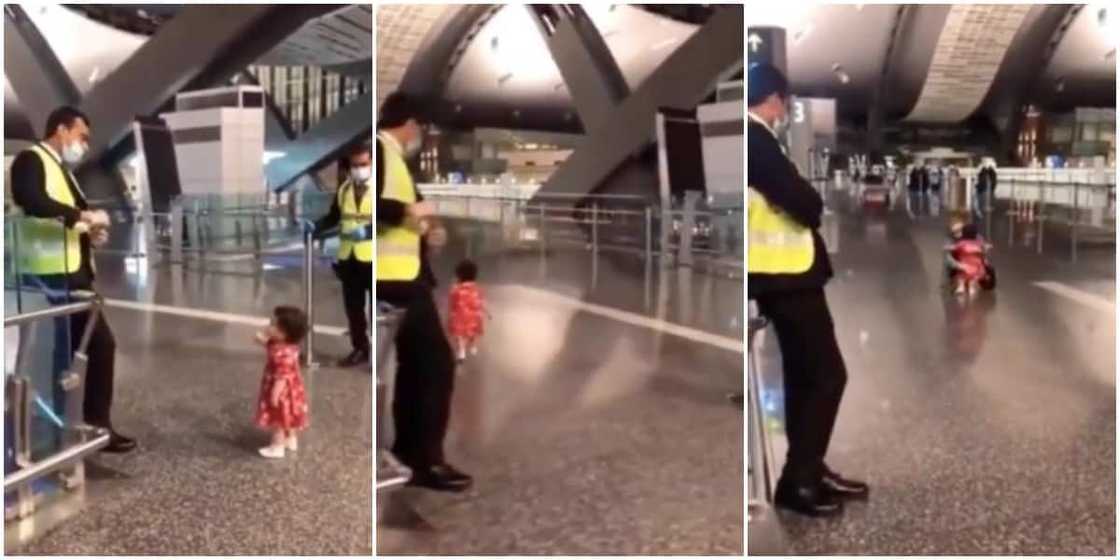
[747, 64, 868, 516]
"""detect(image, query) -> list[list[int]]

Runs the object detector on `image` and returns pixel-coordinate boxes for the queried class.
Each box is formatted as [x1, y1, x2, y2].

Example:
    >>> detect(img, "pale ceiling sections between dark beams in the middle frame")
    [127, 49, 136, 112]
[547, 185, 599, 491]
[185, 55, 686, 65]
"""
[377, 3, 712, 132]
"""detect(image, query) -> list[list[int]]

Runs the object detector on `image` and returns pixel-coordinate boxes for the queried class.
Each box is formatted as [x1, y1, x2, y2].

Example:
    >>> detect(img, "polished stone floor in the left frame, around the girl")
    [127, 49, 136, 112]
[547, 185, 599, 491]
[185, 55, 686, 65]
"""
[10, 256, 373, 556]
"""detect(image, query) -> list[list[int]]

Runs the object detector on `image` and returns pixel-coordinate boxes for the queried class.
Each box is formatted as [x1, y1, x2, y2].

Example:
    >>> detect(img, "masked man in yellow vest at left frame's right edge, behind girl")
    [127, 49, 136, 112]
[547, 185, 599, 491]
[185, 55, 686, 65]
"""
[315, 142, 373, 367]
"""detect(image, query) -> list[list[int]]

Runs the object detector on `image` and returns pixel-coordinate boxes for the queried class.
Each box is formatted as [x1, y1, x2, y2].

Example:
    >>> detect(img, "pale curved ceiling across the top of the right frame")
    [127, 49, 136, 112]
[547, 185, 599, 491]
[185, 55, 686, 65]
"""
[747, 2, 1120, 122]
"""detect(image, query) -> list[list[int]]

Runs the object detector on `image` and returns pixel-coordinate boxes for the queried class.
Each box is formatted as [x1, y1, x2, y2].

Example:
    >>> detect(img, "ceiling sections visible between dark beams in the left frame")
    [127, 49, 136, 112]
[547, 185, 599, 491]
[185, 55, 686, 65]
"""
[4, 4, 373, 139]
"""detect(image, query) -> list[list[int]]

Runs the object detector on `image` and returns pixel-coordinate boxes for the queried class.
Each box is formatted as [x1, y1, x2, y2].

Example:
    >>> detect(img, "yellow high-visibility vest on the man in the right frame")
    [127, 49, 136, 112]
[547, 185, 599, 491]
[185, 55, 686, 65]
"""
[747, 188, 815, 274]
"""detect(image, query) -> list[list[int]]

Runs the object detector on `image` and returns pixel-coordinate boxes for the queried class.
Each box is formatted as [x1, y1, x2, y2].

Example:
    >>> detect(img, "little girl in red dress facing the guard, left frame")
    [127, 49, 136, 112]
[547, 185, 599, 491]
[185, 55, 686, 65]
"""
[256, 306, 308, 459]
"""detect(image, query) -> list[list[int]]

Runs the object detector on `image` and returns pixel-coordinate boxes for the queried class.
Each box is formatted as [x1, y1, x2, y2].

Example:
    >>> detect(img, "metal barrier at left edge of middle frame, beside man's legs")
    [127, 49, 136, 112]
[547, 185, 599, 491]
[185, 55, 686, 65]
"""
[376, 302, 412, 494]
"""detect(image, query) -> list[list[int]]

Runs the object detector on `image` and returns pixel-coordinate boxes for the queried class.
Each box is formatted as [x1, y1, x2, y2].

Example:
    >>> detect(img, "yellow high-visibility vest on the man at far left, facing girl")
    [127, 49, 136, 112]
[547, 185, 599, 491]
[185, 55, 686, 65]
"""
[19, 144, 82, 276]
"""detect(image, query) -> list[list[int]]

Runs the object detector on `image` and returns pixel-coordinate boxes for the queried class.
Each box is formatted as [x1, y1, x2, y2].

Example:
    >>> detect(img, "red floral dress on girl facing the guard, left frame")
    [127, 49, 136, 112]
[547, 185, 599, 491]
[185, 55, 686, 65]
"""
[256, 340, 308, 430]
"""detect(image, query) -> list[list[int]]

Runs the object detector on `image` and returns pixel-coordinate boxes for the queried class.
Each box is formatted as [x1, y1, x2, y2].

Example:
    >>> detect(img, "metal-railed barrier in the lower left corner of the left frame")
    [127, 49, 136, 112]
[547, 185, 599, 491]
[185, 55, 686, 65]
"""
[3, 215, 109, 551]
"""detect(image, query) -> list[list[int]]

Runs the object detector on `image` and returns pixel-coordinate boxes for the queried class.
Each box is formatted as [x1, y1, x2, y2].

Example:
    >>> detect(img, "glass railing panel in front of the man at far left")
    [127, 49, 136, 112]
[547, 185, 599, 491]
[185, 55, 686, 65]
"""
[4, 215, 108, 520]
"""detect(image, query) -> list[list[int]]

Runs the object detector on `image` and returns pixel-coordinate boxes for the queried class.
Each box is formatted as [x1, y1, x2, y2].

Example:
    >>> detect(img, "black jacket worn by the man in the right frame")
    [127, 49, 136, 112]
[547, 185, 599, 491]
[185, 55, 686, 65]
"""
[747, 121, 832, 298]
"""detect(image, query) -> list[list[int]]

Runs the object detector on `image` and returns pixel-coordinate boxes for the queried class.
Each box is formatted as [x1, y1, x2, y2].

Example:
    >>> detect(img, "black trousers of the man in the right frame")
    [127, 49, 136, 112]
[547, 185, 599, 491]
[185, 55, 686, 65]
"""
[756, 288, 848, 485]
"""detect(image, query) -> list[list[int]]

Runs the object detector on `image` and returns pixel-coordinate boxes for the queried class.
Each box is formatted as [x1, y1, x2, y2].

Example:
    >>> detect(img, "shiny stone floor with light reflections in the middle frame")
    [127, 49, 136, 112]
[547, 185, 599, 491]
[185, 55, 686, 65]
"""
[376, 224, 744, 554]
